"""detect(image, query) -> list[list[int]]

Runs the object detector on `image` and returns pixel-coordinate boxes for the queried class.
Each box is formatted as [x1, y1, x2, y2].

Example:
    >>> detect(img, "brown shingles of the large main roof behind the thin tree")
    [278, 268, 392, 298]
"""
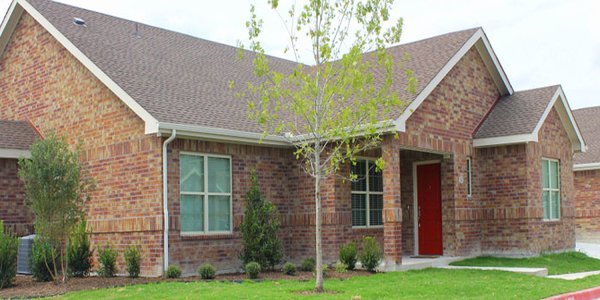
[28, 0, 477, 132]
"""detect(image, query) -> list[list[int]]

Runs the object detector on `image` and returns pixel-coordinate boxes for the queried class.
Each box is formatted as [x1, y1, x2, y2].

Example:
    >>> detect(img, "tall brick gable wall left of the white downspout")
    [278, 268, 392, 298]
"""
[0, 13, 162, 275]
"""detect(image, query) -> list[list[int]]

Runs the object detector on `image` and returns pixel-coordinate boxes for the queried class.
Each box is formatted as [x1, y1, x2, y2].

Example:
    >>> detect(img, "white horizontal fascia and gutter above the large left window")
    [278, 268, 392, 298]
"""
[158, 122, 292, 147]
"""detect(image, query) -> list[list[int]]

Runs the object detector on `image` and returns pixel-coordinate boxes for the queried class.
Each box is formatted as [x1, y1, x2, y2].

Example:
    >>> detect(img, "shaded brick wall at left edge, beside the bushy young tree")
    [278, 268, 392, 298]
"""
[0, 158, 33, 236]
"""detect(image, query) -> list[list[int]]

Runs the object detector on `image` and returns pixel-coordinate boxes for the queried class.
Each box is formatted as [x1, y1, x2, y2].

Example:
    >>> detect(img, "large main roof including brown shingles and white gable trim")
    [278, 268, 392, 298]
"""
[0, 0, 512, 144]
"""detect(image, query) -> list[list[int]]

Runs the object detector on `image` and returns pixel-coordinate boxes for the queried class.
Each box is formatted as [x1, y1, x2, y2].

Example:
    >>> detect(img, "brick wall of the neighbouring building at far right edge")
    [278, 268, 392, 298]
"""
[574, 170, 600, 242]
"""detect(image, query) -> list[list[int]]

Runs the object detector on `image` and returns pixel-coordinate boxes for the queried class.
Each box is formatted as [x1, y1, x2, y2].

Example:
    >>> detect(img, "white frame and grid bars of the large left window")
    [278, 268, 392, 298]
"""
[179, 151, 233, 236]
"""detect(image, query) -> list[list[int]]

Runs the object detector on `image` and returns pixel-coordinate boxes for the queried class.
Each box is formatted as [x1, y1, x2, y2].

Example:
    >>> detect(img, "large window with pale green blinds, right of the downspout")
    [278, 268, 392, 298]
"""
[179, 153, 231, 234]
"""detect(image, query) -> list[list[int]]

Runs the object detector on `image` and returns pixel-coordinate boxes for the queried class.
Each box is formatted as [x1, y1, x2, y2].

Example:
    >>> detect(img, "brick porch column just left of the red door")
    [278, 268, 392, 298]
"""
[381, 136, 402, 269]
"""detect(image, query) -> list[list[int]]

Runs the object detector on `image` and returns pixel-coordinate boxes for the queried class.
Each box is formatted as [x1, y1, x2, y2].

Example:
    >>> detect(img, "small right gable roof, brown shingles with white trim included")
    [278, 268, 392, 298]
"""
[473, 85, 586, 152]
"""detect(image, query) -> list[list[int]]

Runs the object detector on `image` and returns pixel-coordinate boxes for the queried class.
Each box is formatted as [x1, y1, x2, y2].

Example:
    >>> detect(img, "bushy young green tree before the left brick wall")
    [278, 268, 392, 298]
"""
[19, 134, 91, 281]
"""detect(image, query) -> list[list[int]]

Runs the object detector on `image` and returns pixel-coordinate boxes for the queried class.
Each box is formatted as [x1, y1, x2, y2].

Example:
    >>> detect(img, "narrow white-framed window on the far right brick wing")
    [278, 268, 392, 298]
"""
[542, 159, 560, 220]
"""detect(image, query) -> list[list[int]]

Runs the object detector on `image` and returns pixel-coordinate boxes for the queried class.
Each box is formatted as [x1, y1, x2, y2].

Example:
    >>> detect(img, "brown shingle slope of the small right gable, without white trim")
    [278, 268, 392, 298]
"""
[475, 85, 559, 139]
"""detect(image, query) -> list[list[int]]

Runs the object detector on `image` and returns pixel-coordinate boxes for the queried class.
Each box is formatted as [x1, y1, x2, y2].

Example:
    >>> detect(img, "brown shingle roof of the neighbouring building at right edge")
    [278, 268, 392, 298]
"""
[573, 106, 600, 164]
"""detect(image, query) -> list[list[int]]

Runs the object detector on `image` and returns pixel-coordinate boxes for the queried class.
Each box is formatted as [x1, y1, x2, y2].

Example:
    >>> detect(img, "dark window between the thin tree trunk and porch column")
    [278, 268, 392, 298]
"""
[352, 160, 383, 227]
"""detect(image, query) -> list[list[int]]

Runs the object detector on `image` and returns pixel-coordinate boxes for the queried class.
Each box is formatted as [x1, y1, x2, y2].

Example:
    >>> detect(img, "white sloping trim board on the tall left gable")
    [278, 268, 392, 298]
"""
[0, 0, 158, 134]
